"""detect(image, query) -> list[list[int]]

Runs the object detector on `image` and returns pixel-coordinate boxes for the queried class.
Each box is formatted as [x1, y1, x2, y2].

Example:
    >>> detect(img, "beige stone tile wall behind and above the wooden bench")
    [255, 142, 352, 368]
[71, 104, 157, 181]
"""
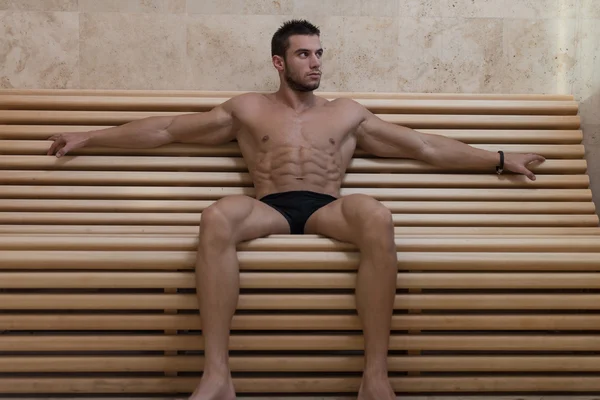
[0, 0, 600, 217]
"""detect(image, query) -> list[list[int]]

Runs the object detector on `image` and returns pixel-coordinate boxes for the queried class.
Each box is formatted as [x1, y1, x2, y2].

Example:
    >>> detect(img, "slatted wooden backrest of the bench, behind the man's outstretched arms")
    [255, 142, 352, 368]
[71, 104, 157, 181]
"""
[0, 90, 598, 235]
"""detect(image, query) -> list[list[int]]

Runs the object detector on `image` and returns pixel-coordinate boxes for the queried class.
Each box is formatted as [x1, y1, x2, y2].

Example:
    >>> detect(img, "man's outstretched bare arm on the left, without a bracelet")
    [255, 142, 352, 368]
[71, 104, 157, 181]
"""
[47, 99, 237, 157]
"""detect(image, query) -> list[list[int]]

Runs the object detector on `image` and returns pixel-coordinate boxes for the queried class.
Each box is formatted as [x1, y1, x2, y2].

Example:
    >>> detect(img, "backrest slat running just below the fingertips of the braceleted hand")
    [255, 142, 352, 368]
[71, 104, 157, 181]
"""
[0, 170, 590, 189]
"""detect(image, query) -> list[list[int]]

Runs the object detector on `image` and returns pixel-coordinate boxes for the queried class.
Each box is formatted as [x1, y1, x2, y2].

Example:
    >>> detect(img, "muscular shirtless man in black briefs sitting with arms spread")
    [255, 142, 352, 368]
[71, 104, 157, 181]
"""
[48, 20, 544, 400]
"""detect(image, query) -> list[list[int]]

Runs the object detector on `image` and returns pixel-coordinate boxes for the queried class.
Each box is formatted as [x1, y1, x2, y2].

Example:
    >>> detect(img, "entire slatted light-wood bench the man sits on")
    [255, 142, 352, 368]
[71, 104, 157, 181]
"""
[0, 90, 600, 395]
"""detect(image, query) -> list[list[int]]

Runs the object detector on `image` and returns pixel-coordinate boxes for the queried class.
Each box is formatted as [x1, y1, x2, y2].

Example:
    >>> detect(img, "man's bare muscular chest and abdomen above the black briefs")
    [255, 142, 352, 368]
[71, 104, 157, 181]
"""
[232, 96, 356, 198]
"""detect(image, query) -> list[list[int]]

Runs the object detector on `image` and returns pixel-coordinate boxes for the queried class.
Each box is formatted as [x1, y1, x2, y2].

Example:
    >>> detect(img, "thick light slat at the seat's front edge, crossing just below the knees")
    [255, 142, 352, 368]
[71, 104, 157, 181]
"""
[0, 250, 598, 271]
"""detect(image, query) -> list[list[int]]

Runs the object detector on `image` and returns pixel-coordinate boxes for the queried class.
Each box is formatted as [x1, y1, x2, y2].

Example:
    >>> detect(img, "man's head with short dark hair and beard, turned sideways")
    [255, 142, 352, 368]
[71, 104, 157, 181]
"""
[271, 20, 323, 92]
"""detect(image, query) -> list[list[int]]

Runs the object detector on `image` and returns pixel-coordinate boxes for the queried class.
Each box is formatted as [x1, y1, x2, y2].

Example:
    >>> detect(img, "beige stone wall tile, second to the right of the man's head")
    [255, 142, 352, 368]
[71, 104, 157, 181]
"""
[398, 18, 504, 93]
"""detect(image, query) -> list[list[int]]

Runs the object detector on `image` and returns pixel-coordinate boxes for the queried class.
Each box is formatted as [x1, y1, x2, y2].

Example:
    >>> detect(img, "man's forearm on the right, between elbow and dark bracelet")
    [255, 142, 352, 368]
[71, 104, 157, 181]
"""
[424, 135, 500, 171]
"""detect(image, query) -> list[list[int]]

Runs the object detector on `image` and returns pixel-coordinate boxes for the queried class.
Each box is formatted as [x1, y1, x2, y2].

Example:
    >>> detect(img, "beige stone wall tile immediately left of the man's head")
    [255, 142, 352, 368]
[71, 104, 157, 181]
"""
[186, 15, 286, 90]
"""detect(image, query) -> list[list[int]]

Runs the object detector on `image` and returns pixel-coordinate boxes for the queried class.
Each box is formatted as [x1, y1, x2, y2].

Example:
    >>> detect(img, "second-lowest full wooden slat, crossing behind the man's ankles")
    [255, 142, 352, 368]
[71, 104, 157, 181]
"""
[0, 355, 600, 373]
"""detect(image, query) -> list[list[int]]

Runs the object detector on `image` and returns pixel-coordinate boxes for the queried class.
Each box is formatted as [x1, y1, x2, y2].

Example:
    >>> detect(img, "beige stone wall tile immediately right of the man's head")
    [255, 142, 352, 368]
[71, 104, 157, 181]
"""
[322, 17, 398, 92]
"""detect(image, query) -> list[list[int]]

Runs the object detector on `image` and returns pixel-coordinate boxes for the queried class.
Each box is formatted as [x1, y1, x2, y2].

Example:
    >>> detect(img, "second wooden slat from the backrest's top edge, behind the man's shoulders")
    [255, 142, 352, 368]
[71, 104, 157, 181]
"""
[0, 95, 578, 115]
